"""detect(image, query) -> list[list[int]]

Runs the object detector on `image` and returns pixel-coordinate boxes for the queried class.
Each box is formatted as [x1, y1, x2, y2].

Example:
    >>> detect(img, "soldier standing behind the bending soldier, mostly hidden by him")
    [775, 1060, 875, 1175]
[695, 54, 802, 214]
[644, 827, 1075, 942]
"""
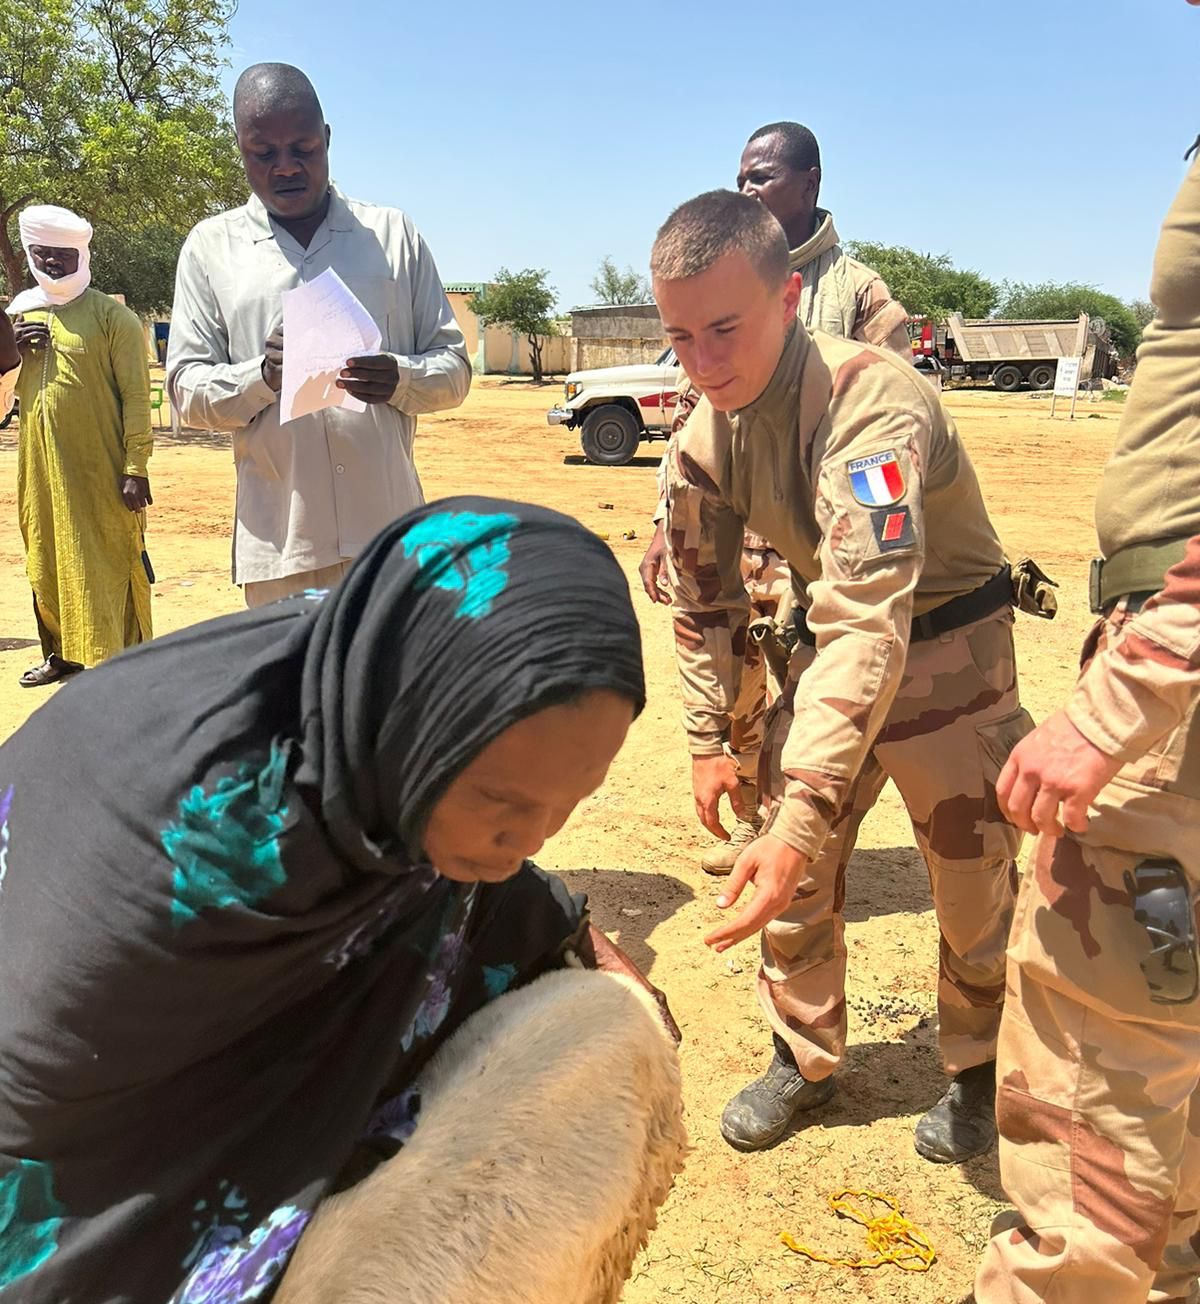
[639, 123, 912, 875]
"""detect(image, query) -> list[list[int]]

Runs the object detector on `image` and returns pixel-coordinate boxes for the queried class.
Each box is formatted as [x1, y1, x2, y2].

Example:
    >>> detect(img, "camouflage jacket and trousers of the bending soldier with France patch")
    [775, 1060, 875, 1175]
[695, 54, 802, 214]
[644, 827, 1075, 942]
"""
[668, 326, 1028, 1081]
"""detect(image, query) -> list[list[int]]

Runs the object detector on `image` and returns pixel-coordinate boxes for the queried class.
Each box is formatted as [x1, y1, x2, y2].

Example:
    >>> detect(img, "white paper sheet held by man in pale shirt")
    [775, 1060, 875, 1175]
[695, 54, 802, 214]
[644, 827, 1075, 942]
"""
[279, 267, 383, 424]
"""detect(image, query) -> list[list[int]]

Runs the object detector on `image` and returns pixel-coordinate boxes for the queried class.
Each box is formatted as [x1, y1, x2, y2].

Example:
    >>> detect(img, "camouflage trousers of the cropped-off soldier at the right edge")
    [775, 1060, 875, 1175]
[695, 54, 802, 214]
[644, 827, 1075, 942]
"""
[976, 610, 1200, 1304]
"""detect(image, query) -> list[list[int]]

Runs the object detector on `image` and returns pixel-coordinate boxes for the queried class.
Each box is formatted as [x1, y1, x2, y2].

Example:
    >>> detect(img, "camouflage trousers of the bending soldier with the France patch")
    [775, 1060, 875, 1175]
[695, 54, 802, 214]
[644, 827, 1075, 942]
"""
[758, 610, 1032, 1080]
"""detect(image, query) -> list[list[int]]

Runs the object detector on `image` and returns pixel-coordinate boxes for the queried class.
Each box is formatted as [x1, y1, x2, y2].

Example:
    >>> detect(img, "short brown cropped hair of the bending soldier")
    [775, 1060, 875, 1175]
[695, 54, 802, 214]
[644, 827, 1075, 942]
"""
[650, 190, 788, 286]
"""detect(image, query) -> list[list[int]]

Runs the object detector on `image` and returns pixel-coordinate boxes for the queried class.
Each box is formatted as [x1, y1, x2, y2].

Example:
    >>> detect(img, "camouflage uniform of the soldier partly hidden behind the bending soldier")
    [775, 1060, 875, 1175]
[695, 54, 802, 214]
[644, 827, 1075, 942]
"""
[655, 209, 913, 781]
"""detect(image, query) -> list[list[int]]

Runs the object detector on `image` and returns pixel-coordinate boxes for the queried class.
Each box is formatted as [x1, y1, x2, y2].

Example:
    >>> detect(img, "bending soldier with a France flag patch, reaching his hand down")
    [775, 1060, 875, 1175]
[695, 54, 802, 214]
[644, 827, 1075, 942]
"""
[651, 190, 1029, 1161]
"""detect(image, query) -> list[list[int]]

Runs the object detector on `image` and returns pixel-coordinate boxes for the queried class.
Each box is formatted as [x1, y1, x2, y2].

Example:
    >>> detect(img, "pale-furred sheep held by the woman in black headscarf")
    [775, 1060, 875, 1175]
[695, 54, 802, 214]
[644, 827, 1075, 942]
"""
[277, 969, 686, 1304]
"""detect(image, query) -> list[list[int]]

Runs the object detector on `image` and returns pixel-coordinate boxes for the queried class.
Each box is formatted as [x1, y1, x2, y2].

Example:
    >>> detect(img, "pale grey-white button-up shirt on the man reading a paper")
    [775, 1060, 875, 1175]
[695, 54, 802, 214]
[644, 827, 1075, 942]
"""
[167, 189, 471, 584]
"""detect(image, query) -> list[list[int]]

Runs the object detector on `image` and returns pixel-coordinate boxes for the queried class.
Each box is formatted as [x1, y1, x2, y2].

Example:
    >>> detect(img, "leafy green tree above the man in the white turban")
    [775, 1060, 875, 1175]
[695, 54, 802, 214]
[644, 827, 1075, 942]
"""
[0, 0, 245, 297]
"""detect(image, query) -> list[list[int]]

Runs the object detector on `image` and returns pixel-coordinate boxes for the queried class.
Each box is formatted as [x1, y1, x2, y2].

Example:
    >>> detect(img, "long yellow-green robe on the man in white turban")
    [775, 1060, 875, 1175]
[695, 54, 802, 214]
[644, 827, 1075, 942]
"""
[17, 289, 154, 665]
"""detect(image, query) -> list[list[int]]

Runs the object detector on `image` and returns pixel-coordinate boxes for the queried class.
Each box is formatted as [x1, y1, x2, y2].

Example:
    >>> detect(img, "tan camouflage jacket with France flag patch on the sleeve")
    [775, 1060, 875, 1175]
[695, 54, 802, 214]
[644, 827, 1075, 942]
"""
[667, 323, 1003, 855]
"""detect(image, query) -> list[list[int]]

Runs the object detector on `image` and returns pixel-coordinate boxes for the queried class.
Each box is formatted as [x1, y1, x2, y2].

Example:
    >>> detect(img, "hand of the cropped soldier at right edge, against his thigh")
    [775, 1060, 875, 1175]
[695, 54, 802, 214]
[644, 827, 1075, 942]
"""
[991, 711, 1120, 834]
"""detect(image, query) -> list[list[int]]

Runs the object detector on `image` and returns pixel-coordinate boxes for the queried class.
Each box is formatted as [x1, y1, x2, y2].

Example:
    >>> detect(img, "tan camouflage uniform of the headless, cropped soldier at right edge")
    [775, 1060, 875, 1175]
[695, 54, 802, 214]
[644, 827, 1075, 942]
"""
[976, 148, 1200, 1304]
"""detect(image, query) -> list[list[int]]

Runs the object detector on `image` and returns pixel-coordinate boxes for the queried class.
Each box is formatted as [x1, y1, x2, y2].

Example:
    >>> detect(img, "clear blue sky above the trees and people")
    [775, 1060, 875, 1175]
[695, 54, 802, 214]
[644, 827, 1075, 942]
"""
[228, 0, 1200, 308]
